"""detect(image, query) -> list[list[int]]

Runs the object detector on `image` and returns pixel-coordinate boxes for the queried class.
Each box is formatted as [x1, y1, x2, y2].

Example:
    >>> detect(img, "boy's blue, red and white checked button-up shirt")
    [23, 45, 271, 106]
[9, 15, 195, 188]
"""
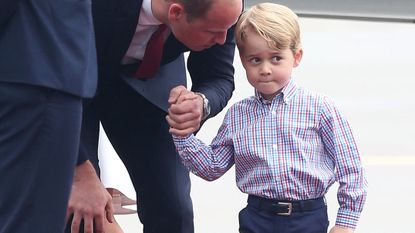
[173, 81, 367, 228]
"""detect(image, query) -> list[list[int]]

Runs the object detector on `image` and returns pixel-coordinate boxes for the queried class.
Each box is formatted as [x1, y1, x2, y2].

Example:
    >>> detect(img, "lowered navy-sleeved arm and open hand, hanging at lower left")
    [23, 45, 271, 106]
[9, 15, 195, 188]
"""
[67, 100, 113, 233]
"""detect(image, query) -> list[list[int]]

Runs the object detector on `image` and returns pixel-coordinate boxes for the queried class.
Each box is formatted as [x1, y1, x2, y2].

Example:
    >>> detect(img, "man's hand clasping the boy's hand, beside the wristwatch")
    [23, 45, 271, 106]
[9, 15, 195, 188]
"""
[166, 86, 203, 137]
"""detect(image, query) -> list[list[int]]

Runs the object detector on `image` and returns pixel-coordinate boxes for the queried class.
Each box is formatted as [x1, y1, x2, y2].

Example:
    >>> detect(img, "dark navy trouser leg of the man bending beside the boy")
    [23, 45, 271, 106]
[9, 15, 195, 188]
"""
[99, 79, 193, 233]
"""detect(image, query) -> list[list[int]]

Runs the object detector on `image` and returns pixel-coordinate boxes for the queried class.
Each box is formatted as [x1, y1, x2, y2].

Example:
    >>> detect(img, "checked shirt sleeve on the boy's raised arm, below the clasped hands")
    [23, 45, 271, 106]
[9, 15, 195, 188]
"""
[173, 110, 234, 181]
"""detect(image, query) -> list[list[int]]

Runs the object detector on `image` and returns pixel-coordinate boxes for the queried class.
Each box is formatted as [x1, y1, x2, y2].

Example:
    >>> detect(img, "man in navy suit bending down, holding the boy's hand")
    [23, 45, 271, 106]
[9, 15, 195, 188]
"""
[68, 0, 242, 233]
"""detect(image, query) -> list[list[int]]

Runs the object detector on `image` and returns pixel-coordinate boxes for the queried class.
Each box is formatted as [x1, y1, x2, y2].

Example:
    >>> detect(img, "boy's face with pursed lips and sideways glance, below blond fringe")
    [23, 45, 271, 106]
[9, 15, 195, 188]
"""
[239, 29, 303, 99]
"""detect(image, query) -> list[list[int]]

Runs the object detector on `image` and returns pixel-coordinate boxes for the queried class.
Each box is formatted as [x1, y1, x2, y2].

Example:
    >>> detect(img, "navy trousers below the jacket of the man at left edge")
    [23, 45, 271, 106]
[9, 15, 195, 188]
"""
[0, 83, 81, 233]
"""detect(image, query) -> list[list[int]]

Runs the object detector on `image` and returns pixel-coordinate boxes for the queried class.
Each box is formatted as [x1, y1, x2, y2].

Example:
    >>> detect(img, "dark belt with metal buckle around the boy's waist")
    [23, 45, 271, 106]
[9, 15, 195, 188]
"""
[248, 195, 326, 216]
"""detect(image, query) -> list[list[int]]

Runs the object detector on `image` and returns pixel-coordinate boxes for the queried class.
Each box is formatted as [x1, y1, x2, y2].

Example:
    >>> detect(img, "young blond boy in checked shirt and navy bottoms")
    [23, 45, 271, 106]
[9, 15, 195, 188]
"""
[167, 3, 367, 233]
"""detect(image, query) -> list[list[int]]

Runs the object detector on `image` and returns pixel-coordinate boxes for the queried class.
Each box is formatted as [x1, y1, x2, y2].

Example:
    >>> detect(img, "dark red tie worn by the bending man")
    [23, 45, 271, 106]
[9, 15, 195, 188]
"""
[134, 24, 167, 79]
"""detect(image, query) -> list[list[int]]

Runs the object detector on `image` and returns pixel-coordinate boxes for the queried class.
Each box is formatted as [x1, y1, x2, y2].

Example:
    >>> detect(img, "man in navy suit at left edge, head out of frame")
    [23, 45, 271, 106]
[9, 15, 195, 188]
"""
[0, 0, 101, 233]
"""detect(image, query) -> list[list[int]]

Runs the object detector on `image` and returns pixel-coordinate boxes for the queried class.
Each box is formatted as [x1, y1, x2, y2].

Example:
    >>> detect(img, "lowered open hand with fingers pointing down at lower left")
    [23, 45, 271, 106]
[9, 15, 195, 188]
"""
[66, 161, 114, 233]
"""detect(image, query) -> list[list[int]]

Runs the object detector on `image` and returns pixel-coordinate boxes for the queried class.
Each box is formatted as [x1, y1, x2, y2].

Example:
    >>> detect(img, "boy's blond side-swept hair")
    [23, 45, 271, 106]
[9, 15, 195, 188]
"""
[235, 3, 301, 53]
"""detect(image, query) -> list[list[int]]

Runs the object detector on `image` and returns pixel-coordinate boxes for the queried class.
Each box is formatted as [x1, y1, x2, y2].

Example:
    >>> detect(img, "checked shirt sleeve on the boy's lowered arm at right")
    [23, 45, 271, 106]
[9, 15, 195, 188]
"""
[321, 99, 367, 229]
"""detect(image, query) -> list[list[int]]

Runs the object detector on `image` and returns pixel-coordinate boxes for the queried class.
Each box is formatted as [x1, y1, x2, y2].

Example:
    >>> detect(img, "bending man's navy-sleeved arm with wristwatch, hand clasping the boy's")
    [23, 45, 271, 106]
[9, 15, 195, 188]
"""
[166, 23, 235, 136]
